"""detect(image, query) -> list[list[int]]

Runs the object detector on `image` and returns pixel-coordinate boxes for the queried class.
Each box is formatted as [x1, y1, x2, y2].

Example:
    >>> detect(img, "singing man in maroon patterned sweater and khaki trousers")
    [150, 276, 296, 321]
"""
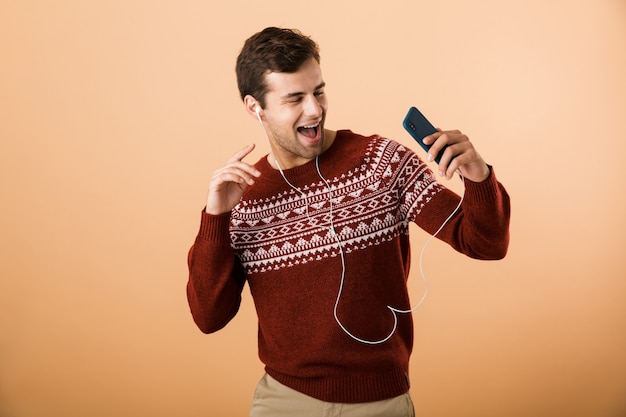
[187, 28, 510, 417]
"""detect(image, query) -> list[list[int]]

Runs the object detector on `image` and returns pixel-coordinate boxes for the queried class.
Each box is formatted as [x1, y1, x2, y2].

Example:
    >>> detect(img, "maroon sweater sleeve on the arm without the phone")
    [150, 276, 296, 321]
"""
[187, 210, 245, 333]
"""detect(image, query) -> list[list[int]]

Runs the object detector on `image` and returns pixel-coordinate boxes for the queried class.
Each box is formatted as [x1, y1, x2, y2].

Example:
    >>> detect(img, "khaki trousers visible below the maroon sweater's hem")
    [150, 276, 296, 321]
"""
[250, 374, 415, 417]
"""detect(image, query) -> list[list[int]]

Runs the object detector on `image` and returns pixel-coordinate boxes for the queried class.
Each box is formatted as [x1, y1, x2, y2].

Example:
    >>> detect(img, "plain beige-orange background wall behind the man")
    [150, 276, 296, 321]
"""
[0, 0, 626, 417]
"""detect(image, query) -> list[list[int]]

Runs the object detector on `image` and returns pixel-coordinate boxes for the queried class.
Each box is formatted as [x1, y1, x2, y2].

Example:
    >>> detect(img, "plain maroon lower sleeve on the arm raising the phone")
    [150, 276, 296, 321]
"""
[416, 167, 511, 260]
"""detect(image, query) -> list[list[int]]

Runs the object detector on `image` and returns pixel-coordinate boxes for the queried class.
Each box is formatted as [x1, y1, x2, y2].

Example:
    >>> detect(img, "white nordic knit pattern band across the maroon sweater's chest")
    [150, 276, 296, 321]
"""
[231, 132, 441, 274]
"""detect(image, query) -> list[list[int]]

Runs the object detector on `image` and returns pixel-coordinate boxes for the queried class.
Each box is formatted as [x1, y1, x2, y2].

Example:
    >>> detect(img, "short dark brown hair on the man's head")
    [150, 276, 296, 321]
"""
[236, 27, 320, 107]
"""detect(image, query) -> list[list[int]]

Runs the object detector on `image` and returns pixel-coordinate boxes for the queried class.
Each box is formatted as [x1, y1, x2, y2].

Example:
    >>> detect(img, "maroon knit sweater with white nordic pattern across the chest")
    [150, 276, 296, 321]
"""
[187, 130, 509, 403]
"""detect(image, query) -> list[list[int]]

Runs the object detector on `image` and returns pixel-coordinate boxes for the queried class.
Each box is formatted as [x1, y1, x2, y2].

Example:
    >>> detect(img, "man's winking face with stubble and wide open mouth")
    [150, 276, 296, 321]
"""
[263, 58, 329, 169]
